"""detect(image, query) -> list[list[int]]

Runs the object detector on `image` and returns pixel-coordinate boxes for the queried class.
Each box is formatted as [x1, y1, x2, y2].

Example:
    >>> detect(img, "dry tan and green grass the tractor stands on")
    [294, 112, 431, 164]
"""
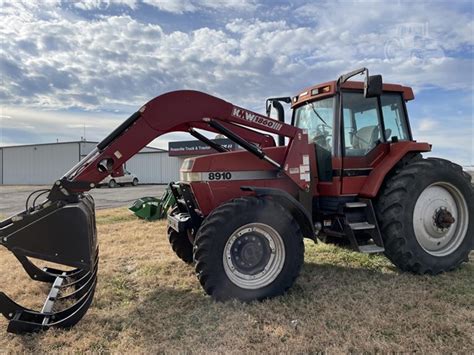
[0, 209, 474, 353]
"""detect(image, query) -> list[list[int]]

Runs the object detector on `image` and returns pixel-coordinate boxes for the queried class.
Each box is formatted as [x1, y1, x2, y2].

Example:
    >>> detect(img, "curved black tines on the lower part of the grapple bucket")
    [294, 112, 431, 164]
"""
[0, 250, 99, 334]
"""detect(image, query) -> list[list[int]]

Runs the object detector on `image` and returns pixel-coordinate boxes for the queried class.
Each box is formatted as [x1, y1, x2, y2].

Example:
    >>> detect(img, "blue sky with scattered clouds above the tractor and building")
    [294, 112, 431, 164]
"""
[0, 0, 474, 165]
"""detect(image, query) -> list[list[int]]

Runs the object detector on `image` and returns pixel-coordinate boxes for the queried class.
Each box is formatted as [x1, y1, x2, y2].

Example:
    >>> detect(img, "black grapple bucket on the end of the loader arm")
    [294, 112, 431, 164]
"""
[0, 195, 99, 333]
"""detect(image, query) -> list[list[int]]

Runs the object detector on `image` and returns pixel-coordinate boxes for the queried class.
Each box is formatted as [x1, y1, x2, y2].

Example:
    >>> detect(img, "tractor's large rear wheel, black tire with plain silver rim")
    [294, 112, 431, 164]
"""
[376, 158, 474, 274]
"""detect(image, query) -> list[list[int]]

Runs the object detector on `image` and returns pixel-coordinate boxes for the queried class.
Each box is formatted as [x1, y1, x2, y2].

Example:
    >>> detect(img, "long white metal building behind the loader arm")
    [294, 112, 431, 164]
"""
[0, 141, 184, 185]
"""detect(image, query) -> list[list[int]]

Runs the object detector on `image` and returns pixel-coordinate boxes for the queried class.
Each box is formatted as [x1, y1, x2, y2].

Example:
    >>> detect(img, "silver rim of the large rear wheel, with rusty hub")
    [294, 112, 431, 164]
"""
[413, 182, 469, 256]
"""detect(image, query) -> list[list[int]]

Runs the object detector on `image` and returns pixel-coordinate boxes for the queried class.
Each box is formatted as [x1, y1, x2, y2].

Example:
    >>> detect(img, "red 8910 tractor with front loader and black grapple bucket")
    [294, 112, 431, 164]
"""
[0, 68, 474, 333]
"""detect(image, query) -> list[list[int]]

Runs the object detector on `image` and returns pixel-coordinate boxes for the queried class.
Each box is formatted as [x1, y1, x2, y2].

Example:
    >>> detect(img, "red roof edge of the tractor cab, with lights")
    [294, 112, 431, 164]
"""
[291, 80, 415, 108]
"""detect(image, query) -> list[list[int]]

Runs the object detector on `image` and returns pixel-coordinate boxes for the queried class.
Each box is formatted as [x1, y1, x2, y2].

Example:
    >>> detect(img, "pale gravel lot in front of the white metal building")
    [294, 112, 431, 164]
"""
[0, 185, 166, 217]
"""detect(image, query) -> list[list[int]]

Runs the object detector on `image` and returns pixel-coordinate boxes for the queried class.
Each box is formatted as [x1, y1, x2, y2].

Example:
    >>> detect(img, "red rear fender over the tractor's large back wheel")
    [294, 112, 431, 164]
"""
[360, 142, 431, 198]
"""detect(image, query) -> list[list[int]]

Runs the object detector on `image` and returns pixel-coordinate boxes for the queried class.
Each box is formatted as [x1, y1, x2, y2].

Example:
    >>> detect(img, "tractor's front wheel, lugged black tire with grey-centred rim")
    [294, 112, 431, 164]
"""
[194, 197, 304, 301]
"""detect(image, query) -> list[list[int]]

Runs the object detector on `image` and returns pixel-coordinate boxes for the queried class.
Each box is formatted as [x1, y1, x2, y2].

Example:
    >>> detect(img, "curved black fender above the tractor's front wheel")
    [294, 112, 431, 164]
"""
[240, 186, 317, 242]
